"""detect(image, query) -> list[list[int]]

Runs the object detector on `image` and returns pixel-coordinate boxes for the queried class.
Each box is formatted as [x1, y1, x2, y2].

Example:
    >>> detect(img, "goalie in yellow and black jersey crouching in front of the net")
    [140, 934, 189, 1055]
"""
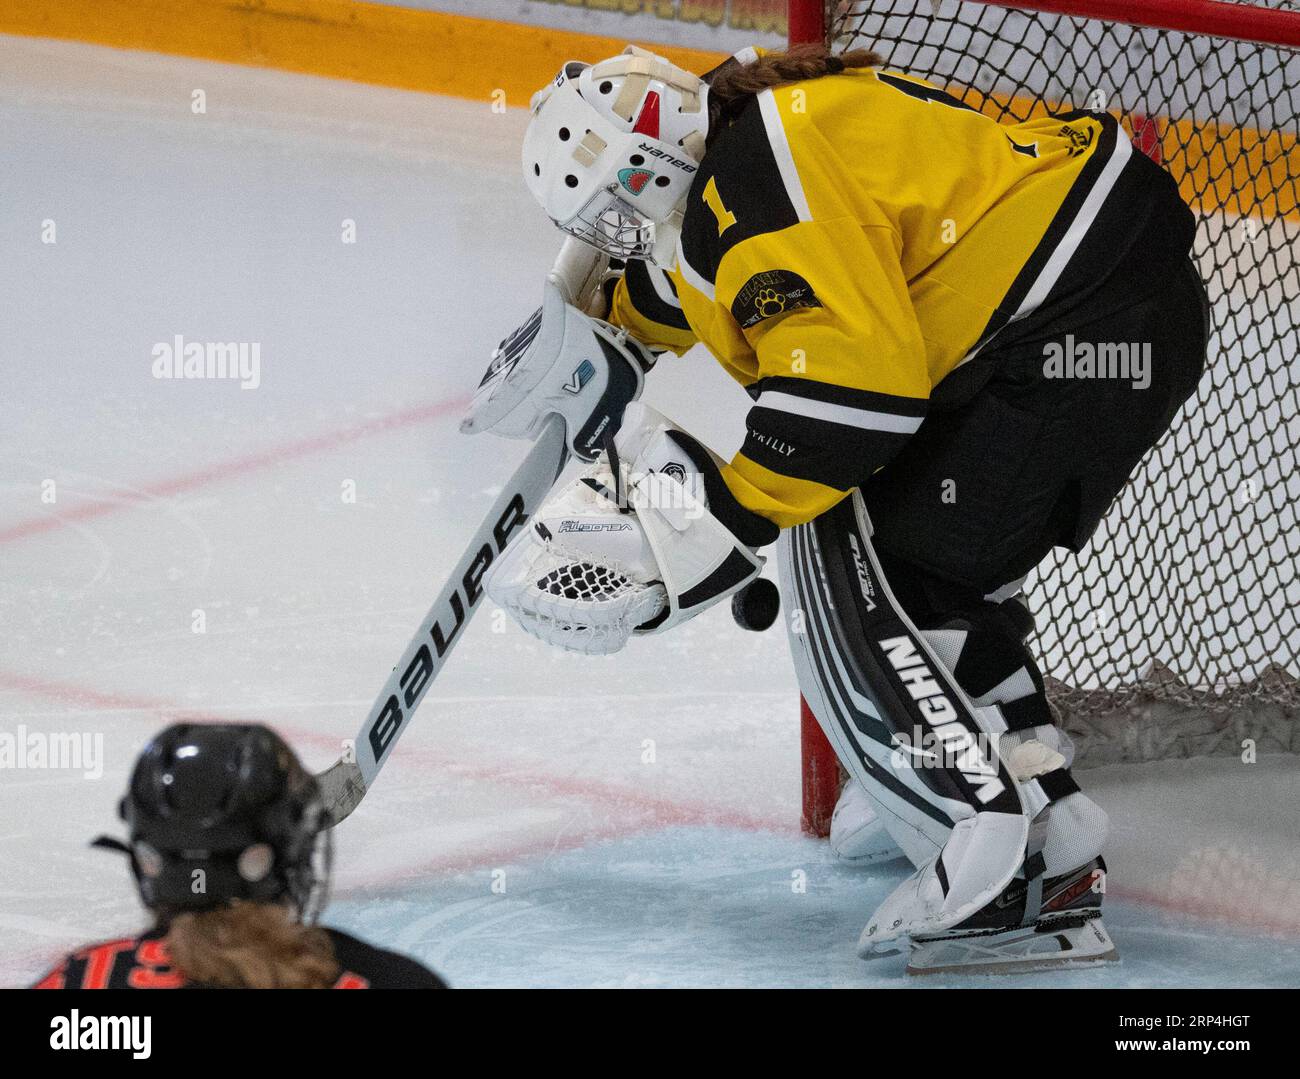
[465, 47, 1208, 971]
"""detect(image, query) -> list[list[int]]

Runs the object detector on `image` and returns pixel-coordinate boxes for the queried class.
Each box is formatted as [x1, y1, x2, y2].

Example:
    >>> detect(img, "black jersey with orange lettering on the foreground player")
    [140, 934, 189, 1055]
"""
[31, 928, 447, 989]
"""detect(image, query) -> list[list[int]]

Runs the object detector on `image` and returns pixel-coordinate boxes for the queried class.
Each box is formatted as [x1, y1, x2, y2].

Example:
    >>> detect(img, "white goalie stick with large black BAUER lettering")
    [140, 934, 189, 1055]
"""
[316, 416, 569, 827]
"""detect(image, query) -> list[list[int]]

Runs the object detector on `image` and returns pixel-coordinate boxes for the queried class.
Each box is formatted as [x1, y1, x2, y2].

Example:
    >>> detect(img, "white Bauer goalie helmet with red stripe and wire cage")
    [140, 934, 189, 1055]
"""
[524, 46, 709, 268]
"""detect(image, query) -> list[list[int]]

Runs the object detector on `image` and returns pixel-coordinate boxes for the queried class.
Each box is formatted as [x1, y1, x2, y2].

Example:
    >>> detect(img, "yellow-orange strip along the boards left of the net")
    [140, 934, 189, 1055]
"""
[0, 0, 724, 107]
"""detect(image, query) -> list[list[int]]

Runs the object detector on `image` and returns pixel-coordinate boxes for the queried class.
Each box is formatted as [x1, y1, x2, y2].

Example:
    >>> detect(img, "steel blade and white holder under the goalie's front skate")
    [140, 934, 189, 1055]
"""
[907, 918, 1119, 976]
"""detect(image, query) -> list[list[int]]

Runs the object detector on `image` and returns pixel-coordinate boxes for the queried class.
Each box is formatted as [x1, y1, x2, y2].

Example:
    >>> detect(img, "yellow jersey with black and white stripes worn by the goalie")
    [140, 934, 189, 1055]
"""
[611, 61, 1191, 528]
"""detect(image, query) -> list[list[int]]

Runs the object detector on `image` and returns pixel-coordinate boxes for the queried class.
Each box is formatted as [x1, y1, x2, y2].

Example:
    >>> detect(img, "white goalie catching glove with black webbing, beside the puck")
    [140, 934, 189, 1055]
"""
[486, 402, 779, 655]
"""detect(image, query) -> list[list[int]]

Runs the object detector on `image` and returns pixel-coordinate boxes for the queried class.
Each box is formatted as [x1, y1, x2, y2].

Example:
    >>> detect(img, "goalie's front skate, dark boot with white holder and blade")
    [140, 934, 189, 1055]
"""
[907, 858, 1119, 975]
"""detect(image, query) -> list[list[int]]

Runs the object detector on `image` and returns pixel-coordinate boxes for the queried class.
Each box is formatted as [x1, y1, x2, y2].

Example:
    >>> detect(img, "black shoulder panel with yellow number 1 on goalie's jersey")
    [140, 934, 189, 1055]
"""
[681, 98, 800, 283]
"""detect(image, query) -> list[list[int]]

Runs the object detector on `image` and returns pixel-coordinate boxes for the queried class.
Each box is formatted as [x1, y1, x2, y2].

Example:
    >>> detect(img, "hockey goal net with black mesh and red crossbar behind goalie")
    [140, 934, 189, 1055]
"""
[790, 0, 1300, 831]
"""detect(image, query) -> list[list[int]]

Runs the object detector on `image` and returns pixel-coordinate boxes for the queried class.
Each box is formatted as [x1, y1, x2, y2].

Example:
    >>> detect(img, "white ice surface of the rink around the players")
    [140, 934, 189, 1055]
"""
[0, 38, 1300, 985]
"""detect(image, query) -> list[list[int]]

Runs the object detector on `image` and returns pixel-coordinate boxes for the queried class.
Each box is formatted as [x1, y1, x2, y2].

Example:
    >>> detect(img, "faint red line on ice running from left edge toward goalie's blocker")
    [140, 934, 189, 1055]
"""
[0, 398, 468, 543]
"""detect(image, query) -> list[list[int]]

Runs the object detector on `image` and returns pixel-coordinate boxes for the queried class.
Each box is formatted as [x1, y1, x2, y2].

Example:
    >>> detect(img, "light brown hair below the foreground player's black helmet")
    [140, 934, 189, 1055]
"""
[165, 902, 342, 989]
